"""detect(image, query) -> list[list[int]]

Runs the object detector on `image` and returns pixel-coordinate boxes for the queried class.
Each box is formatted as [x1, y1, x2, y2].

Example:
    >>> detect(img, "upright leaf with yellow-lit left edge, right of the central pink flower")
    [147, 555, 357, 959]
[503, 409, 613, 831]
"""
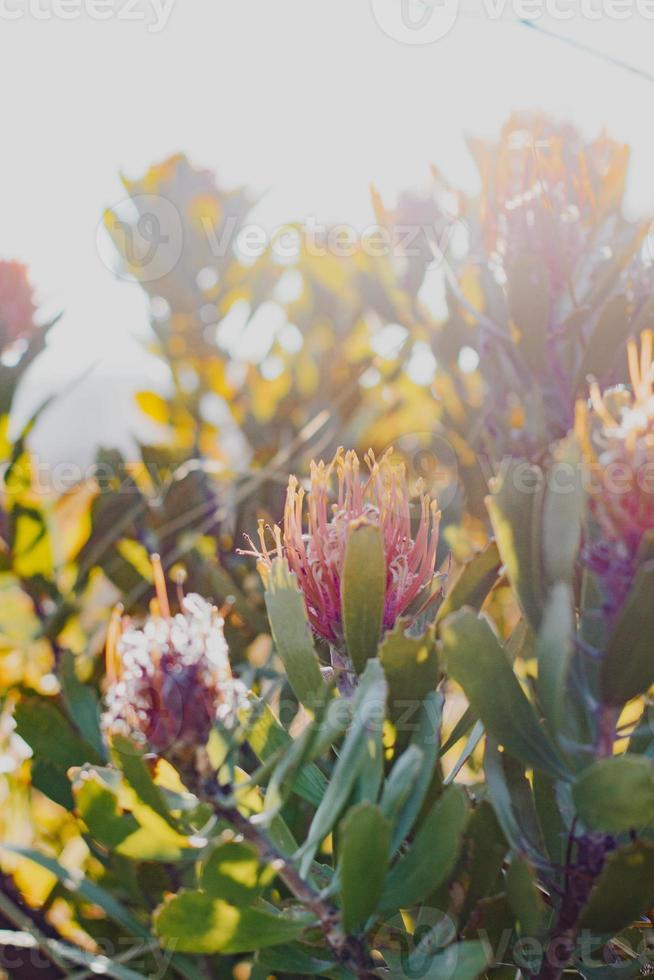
[486, 460, 545, 630]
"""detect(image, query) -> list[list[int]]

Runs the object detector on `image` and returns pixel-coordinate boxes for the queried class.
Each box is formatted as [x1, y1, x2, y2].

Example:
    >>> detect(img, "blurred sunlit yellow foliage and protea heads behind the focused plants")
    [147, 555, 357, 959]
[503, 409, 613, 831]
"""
[0, 113, 654, 975]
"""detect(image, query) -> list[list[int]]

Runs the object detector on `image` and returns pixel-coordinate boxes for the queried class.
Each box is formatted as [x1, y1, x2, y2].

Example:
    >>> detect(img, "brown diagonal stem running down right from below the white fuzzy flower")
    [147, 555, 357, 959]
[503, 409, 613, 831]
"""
[192, 774, 376, 980]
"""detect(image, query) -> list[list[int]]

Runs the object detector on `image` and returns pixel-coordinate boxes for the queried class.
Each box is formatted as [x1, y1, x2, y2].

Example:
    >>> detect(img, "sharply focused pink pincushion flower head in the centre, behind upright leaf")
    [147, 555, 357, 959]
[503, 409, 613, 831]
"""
[250, 449, 440, 646]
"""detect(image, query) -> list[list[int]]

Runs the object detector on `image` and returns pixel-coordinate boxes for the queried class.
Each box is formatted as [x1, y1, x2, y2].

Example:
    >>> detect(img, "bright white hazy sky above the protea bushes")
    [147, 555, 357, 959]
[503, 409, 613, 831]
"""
[0, 0, 654, 462]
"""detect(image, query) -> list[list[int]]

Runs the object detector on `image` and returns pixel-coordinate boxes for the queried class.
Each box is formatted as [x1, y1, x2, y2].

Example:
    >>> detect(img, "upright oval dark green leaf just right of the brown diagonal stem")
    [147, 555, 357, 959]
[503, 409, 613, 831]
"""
[338, 803, 391, 933]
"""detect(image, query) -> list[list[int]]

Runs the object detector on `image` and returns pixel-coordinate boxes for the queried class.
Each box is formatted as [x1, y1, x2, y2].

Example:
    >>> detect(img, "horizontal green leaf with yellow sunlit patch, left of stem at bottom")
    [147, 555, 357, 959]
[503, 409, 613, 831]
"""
[154, 889, 310, 955]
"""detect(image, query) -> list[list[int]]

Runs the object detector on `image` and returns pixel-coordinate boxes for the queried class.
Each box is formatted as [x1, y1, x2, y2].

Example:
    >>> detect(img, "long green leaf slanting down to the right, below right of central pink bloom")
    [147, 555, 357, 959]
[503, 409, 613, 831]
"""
[441, 610, 565, 775]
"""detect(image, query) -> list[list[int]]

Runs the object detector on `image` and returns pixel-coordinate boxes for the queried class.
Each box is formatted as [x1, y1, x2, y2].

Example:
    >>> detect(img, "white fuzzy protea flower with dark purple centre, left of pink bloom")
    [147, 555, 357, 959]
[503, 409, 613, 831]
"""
[103, 555, 246, 755]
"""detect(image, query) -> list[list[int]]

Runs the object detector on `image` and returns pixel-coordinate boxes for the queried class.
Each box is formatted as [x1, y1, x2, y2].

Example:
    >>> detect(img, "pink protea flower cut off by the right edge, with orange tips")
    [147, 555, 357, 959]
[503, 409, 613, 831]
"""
[576, 330, 654, 610]
